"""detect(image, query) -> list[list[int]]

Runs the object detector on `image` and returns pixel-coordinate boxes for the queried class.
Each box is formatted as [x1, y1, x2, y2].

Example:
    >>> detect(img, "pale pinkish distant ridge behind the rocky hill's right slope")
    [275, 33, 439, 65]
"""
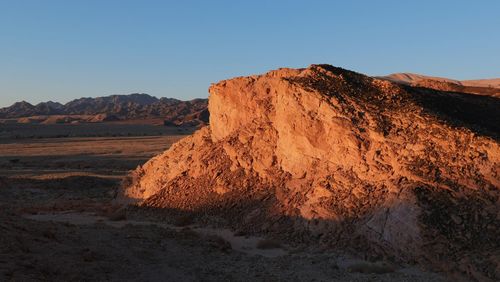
[377, 73, 500, 97]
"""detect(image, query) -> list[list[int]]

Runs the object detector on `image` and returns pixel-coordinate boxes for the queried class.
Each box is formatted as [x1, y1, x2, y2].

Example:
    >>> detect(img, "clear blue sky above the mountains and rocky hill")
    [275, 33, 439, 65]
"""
[0, 0, 500, 106]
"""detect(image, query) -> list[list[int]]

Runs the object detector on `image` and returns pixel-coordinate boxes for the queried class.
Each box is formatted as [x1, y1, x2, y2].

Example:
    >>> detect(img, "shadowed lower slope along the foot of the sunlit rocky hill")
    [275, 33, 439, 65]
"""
[122, 183, 500, 280]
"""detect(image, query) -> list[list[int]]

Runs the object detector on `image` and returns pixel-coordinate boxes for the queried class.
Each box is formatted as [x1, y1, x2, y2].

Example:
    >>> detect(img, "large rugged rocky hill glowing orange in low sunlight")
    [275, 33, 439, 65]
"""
[122, 65, 500, 276]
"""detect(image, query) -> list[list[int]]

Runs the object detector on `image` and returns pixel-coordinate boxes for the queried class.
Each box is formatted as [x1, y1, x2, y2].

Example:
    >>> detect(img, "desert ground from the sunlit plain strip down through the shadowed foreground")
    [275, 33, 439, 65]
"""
[0, 133, 445, 281]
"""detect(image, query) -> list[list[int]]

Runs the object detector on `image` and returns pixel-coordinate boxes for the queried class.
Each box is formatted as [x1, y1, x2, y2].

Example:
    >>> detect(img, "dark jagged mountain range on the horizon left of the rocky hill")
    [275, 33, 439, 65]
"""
[0, 94, 208, 126]
